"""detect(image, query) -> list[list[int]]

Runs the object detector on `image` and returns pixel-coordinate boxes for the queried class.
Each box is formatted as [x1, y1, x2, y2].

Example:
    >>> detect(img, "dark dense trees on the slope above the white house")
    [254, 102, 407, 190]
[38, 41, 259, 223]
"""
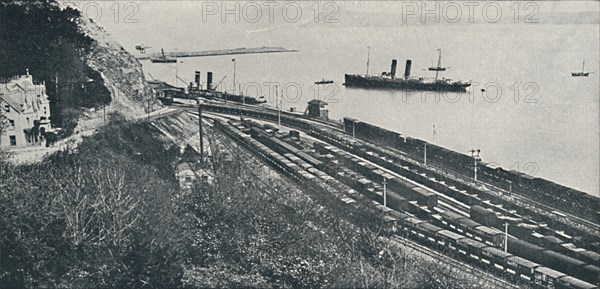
[0, 0, 111, 134]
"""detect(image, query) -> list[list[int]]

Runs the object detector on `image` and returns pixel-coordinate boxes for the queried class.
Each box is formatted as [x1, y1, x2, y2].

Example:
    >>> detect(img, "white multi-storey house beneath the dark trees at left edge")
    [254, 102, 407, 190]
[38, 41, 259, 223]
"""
[0, 71, 52, 147]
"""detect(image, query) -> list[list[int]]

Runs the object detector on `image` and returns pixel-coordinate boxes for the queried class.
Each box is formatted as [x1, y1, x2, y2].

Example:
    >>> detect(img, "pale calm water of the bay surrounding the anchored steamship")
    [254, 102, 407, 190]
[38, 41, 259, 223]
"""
[85, 1, 600, 195]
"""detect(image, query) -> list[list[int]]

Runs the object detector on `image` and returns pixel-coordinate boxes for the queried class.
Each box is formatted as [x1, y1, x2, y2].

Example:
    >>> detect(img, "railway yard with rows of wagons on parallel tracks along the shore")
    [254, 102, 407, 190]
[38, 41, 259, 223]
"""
[175, 102, 600, 288]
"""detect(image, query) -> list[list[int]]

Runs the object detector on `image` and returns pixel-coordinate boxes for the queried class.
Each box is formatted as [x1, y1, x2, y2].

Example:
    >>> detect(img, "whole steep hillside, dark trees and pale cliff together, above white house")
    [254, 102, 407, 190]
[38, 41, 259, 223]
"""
[0, 0, 160, 137]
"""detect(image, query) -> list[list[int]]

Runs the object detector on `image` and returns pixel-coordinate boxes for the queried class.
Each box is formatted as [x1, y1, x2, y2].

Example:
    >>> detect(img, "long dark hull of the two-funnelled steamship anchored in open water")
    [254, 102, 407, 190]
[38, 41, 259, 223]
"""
[344, 74, 471, 92]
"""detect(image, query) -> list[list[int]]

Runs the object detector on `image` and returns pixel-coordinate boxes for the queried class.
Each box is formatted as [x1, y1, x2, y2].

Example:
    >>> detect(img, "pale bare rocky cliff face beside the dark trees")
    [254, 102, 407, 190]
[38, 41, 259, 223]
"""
[72, 17, 162, 131]
